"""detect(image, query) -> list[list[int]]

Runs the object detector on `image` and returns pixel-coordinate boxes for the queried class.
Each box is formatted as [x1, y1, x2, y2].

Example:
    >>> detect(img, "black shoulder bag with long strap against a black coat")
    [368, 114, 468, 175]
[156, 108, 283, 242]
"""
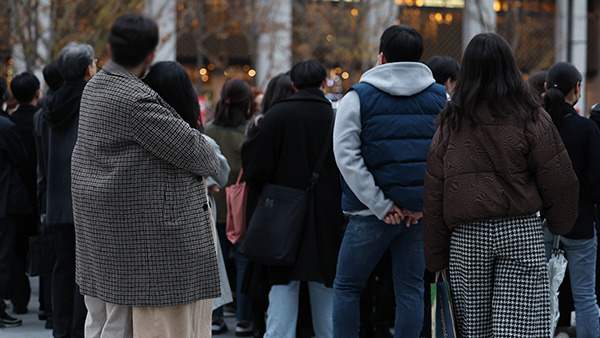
[239, 120, 333, 266]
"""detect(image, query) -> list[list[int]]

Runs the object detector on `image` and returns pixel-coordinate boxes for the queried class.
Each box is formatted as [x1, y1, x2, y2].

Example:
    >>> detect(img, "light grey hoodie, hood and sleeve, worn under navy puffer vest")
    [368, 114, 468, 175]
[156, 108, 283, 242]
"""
[333, 62, 435, 219]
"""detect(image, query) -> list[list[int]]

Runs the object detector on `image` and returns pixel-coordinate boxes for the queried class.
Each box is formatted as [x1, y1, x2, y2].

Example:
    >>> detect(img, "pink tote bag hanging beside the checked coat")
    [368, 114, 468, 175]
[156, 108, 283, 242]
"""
[225, 169, 248, 244]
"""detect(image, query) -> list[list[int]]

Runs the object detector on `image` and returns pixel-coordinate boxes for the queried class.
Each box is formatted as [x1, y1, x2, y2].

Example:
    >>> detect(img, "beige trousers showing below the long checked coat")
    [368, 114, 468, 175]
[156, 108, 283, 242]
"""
[85, 296, 213, 338]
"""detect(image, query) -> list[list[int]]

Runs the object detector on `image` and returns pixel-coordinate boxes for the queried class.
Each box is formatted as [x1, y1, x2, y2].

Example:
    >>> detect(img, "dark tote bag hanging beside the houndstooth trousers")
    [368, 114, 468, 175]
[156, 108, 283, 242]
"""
[431, 272, 456, 338]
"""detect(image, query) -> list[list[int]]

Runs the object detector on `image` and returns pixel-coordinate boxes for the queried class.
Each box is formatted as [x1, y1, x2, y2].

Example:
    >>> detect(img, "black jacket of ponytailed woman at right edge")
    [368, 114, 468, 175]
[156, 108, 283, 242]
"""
[558, 103, 600, 239]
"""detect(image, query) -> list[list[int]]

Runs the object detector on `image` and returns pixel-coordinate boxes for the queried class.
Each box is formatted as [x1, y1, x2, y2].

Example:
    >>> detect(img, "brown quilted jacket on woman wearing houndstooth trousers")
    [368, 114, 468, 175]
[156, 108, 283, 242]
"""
[423, 107, 579, 271]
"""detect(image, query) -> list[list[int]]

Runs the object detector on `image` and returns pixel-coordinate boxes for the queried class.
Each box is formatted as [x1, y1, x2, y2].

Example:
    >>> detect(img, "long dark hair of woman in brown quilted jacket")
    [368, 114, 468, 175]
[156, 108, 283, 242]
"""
[438, 33, 539, 129]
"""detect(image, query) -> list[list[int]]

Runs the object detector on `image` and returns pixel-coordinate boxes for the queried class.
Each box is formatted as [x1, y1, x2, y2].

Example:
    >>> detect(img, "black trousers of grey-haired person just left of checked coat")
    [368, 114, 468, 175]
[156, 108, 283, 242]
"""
[52, 224, 87, 338]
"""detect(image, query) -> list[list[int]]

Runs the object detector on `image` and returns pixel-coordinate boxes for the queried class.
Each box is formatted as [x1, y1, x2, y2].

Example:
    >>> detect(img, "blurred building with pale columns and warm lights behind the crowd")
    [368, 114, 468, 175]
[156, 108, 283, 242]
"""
[0, 0, 600, 112]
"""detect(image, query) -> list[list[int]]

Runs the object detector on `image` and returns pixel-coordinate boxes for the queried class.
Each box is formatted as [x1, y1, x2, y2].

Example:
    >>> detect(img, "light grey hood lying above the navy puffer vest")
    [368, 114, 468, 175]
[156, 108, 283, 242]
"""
[360, 62, 435, 96]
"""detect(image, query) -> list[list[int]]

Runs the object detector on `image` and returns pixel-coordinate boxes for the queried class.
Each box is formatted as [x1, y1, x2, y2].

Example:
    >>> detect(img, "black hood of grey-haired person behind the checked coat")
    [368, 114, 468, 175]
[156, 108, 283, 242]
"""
[44, 79, 86, 127]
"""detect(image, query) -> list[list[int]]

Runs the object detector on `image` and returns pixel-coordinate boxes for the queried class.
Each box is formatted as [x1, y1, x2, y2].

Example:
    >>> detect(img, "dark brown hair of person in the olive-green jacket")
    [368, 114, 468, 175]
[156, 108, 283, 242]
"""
[213, 79, 254, 127]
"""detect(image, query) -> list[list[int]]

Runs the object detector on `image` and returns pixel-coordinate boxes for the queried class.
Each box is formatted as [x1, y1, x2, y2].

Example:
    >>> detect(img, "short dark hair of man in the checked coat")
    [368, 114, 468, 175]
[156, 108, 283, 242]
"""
[108, 14, 158, 67]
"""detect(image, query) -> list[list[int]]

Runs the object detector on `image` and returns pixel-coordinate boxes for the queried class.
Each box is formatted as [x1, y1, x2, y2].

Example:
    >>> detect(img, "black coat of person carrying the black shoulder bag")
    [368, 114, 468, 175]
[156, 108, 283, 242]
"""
[242, 89, 343, 286]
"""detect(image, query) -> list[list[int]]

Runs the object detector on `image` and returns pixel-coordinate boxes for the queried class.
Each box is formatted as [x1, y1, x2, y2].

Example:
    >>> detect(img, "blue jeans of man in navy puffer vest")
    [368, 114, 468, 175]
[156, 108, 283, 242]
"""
[333, 216, 425, 338]
